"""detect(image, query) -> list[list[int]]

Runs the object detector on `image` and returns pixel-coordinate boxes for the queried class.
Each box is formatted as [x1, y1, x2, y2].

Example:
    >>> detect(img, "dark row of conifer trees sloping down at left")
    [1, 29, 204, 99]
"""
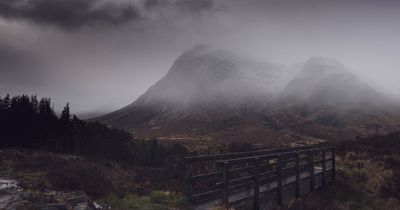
[0, 95, 181, 165]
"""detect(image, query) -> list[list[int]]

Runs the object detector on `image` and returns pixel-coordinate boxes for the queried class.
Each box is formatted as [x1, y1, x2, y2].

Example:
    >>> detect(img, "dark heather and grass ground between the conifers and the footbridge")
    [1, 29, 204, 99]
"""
[0, 148, 187, 210]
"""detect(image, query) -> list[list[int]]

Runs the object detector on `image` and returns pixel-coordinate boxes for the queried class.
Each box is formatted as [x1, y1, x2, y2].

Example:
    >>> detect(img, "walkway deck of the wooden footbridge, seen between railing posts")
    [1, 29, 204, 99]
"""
[194, 166, 332, 210]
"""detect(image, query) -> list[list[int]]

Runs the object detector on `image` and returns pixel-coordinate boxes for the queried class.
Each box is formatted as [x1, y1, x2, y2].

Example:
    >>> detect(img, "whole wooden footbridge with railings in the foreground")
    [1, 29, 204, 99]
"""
[185, 146, 335, 210]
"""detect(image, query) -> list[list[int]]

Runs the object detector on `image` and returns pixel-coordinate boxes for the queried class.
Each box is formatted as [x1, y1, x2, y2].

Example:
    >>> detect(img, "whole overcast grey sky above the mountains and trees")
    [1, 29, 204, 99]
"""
[0, 0, 400, 116]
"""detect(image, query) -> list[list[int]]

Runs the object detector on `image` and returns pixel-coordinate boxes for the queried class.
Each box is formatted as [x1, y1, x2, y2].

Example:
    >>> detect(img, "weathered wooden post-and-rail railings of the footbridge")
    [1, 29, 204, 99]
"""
[185, 146, 336, 209]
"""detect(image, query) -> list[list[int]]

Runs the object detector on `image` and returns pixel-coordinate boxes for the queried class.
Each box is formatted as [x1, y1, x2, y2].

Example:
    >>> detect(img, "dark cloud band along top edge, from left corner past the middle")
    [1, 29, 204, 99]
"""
[0, 0, 214, 29]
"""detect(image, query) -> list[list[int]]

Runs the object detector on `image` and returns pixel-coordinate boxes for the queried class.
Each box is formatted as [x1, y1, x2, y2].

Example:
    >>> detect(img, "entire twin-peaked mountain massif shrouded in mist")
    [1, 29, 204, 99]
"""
[96, 45, 400, 143]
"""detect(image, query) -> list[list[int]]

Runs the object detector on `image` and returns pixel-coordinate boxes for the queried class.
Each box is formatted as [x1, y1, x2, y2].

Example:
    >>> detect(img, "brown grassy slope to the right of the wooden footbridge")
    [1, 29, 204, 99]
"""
[305, 133, 400, 210]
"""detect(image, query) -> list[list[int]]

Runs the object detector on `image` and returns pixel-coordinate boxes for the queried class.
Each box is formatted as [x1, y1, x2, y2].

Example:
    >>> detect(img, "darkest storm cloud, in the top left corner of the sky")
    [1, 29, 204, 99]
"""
[0, 0, 140, 29]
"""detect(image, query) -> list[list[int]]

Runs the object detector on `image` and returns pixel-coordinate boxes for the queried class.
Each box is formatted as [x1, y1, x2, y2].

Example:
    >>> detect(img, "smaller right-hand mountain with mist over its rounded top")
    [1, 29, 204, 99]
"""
[277, 57, 400, 143]
